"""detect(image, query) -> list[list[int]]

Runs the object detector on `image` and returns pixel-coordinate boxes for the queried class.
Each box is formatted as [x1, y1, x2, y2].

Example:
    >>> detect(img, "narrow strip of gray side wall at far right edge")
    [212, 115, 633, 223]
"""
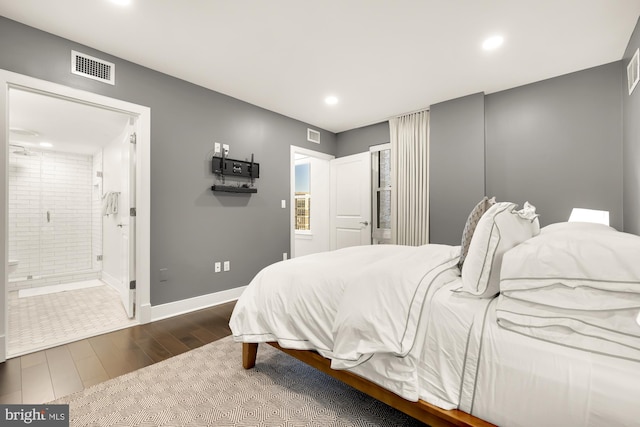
[621, 17, 640, 234]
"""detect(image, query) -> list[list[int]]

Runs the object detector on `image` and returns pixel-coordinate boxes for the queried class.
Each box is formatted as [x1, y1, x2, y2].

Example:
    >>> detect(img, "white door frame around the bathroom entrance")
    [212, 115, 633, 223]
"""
[0, 69, 151, 362]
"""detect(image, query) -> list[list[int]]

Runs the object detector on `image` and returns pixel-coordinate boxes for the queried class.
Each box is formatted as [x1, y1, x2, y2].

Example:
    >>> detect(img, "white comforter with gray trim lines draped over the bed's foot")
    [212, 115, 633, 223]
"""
[229, 245, 460, 404]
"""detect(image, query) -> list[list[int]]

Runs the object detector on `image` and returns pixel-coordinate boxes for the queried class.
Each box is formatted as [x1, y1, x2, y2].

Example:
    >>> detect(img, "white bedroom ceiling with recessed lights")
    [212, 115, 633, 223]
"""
[0, 0, 640, 132]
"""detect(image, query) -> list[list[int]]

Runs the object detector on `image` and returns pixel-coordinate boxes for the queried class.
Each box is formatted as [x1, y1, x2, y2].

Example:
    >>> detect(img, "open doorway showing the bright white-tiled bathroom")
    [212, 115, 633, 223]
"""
[3, 70, 149, 357]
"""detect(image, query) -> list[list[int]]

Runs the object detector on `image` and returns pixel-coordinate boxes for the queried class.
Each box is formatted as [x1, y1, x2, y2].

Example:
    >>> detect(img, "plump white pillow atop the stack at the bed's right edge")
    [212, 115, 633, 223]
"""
[500, 222, 640, 300]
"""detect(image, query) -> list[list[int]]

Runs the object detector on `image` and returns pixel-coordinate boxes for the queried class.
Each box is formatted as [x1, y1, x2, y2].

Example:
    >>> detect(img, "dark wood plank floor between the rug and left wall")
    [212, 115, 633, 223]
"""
[0, 301, 235, 404]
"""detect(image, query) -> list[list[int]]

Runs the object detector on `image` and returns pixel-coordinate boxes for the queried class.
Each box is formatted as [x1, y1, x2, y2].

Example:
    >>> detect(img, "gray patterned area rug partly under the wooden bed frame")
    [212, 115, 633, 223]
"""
[53, 337, 424, 427]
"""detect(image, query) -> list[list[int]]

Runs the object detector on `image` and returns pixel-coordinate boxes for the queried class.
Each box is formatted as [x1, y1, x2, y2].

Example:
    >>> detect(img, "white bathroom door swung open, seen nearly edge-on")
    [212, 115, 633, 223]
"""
[119, 129, 136, 318]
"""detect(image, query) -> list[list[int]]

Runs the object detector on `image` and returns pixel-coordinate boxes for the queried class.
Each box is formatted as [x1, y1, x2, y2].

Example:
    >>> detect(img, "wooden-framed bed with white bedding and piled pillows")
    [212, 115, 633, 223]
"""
[230, 198, 640, 427]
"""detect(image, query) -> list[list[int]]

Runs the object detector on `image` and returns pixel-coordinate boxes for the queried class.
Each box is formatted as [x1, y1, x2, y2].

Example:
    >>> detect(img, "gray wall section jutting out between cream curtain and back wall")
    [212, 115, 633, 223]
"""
[429, 93, 485, 245]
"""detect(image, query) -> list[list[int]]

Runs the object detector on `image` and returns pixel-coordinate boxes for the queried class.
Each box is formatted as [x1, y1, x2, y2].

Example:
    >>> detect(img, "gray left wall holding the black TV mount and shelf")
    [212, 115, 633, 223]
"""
[0, 17, 336, 305]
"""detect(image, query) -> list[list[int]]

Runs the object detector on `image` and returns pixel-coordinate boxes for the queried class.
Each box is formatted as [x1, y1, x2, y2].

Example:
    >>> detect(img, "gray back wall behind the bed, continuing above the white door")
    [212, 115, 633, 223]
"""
[337, 61, 624, 244]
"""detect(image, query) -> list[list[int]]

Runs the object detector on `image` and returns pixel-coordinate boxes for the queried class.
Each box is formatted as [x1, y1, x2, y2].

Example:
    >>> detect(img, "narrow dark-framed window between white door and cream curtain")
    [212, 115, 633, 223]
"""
[371, 144, 392, 244]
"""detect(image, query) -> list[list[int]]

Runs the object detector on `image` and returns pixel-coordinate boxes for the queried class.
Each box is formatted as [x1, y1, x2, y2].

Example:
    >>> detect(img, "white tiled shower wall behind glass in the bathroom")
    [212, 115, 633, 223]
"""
[9, 150, 101, 289]
